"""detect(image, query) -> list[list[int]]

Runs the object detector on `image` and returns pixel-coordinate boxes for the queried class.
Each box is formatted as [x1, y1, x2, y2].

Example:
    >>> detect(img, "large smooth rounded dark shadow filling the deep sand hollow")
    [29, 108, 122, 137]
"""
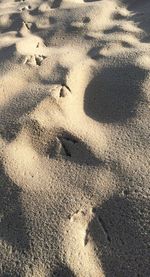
[84, 64, 147, 123]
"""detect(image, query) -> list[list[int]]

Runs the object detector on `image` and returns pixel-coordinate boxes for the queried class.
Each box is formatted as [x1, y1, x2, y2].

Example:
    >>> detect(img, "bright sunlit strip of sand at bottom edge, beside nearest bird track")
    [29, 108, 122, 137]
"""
[65, 207, 105, 277]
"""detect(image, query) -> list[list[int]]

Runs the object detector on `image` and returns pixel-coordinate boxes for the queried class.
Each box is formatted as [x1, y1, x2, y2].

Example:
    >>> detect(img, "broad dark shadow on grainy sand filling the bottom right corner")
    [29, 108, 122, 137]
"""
[89, 195, 150, 277]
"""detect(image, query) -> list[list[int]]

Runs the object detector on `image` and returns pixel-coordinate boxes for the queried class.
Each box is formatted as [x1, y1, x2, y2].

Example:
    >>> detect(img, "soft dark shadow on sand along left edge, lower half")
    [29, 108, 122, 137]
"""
[0, 166, 29, 252]
